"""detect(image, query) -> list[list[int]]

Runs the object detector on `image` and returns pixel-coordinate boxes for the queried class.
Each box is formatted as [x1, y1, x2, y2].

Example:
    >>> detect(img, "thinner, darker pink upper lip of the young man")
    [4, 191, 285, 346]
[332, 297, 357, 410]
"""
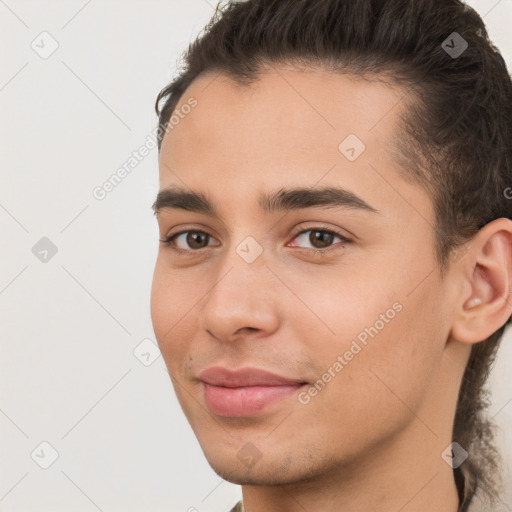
[199, 366, 305, 388]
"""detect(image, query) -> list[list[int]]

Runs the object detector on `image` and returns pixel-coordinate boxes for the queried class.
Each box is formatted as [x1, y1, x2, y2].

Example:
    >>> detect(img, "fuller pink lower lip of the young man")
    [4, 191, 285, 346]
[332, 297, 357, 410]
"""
[203, 382, 302, 417]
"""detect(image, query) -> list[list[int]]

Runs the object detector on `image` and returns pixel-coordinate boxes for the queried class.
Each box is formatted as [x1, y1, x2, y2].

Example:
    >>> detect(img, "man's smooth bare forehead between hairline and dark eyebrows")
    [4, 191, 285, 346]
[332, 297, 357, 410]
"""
[156, 67, 431, 224]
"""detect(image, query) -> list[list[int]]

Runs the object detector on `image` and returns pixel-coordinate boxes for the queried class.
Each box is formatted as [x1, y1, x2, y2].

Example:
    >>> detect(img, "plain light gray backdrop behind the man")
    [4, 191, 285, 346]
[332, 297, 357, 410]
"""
[0, 0, 512, 512]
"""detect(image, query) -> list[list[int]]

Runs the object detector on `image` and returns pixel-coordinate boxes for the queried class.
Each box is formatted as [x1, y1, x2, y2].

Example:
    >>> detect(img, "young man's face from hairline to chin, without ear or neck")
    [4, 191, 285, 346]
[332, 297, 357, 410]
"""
[151, 67, 456, 485]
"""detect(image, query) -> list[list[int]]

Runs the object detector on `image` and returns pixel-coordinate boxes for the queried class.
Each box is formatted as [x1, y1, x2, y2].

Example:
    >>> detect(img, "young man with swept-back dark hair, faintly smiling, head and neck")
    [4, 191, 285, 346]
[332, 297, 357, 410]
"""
[151, 0, 512, 512]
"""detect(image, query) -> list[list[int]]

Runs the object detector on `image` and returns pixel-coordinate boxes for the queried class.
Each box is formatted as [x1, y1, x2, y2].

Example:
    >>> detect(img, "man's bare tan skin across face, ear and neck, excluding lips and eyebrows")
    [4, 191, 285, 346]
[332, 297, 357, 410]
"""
[151, 66, 512, 512]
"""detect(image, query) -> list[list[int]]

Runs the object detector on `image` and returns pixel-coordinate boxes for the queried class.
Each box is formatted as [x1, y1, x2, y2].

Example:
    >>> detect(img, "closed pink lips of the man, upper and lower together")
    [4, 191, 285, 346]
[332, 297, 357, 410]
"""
[199, 366, 305, 417]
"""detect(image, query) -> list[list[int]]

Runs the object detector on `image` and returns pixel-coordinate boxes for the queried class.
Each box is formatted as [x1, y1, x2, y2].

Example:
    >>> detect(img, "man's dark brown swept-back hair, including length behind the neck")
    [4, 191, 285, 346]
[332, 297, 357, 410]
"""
[155, 0, 512, 500]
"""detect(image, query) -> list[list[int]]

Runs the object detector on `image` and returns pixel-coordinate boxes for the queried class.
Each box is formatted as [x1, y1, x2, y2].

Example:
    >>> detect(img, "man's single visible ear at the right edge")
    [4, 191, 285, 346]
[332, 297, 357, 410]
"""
[450, 218, 512, 343]
